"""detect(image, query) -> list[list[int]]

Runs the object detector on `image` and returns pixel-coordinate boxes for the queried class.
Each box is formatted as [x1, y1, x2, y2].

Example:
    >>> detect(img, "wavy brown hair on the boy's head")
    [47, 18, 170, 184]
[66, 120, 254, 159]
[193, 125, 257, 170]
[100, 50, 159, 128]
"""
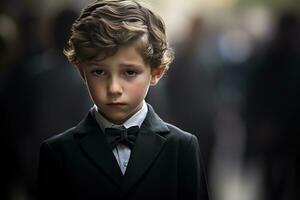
[64, 0, 174, 68]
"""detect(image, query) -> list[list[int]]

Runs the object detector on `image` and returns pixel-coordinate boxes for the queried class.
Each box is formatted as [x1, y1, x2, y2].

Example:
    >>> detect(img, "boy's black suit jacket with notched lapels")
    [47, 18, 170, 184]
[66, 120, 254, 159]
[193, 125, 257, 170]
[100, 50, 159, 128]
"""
[38, 105, 208, 200]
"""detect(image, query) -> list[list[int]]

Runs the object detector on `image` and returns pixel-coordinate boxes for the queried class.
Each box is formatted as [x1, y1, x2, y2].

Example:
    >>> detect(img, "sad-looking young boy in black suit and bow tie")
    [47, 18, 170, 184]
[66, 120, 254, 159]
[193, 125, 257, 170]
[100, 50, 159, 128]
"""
[38, 0, 208, 200]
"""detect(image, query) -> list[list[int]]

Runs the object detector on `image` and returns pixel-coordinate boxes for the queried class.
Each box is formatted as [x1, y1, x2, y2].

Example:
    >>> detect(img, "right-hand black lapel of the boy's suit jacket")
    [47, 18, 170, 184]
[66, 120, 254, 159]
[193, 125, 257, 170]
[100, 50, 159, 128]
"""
[121, 105, 169, 196]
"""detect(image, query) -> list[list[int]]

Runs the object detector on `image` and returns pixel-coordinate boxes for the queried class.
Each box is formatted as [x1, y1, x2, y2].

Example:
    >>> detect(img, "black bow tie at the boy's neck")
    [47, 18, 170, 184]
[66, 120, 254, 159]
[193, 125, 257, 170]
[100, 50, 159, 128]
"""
[105, 126, 140, 149]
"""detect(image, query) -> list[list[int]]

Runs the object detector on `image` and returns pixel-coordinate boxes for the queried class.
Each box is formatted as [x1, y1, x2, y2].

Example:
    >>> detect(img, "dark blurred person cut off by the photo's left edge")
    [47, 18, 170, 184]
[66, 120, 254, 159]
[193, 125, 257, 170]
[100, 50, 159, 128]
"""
[0, 13, 20, 199]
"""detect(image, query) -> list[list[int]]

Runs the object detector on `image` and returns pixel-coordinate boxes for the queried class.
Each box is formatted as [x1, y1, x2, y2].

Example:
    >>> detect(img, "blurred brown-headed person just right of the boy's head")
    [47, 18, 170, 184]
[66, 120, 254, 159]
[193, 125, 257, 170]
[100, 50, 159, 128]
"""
[165, 16, 216, 171]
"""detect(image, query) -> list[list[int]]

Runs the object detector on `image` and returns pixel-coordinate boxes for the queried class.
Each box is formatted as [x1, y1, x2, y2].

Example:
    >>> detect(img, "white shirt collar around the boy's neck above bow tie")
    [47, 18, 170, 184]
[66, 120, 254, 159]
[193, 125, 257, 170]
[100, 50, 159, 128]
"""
[93, 100, 148, 132]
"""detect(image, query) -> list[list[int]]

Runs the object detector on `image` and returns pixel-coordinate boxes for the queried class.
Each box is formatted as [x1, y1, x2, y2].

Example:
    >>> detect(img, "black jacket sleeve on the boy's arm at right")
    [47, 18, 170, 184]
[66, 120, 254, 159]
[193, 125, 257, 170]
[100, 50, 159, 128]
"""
[179, 135, 209, 200]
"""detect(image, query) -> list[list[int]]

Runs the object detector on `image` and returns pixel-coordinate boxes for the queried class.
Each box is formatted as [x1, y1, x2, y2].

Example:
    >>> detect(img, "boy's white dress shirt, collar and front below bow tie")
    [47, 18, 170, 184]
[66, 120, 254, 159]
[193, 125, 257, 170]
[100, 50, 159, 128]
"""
[93, 101, 148, 175]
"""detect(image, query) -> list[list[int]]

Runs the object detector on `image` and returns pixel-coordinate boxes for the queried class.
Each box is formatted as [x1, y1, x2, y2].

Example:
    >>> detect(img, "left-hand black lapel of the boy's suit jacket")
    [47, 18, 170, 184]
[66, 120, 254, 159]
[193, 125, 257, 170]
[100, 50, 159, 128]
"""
[76, 110, 123, 188]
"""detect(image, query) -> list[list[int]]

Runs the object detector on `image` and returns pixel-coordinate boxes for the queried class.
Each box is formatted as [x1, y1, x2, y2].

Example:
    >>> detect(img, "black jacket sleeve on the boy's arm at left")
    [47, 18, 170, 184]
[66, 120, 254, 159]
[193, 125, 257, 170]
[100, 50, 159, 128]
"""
[38, 142, 64, 200]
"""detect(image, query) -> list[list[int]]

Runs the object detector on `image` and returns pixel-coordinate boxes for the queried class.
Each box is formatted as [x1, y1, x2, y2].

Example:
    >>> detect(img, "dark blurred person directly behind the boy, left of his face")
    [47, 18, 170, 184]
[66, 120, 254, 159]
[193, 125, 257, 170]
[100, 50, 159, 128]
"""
[20, 8, 91, 198]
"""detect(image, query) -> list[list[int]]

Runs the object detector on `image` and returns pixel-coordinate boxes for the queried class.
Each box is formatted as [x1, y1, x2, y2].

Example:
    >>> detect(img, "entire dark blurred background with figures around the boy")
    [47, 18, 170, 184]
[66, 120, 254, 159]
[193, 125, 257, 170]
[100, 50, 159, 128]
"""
[0, 0, 300, 200]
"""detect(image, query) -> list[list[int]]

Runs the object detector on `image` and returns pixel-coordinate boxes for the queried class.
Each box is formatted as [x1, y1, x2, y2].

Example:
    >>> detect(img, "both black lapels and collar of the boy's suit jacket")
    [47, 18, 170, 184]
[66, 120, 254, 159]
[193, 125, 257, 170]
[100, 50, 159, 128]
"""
[75, 104, 169, 196]
